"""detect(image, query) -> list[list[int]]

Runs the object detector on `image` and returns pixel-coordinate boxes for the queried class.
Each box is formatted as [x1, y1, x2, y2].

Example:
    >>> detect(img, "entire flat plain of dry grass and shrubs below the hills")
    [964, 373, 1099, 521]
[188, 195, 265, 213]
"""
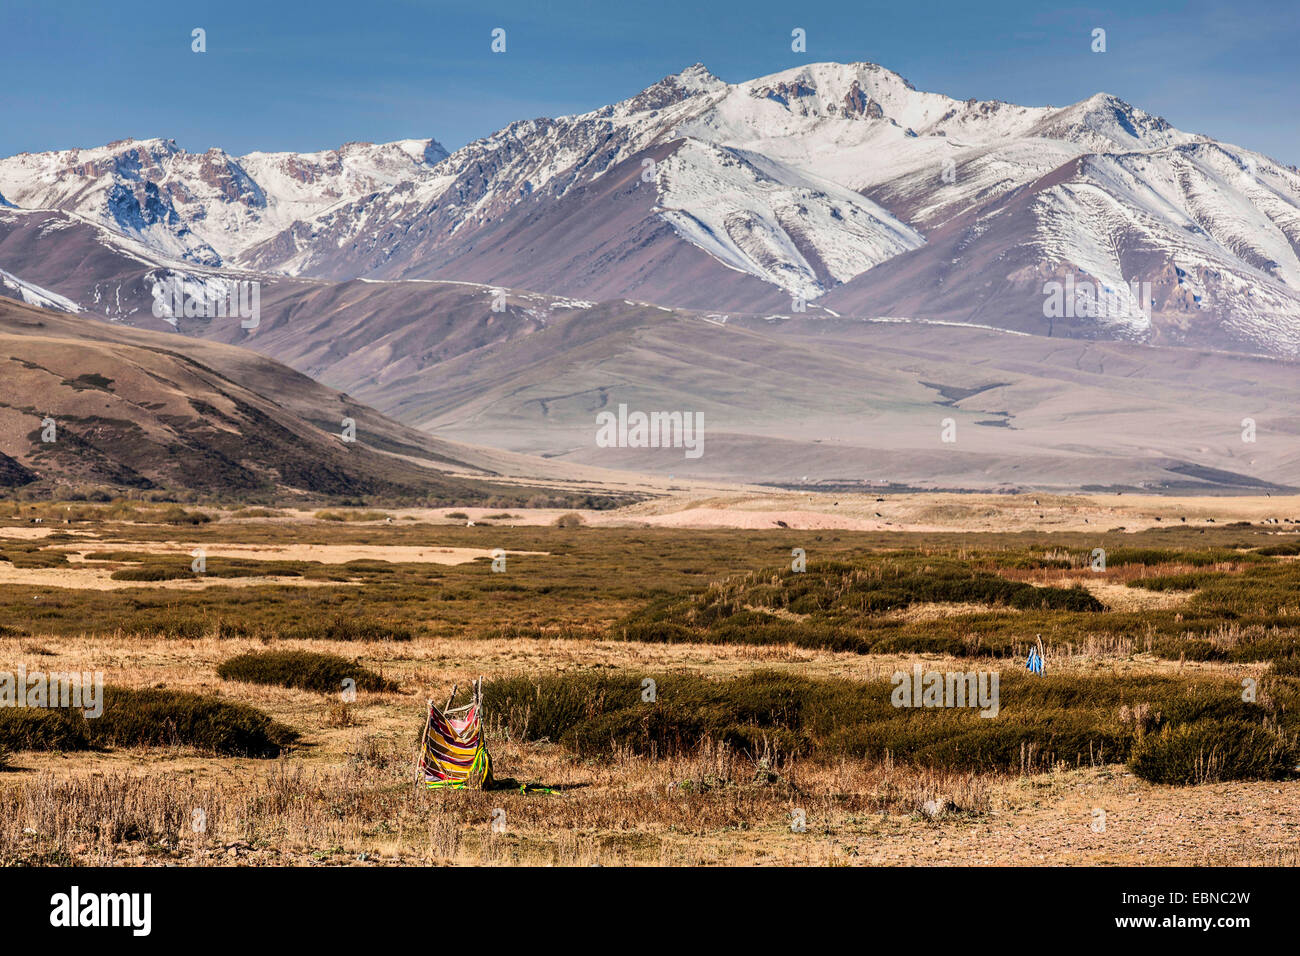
[0, 492, 1300, 866]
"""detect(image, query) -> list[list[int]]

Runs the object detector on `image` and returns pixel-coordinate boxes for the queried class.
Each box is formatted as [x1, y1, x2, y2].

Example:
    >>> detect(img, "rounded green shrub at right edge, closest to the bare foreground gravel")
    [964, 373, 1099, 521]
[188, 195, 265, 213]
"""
[1128, 721, 1297, 784]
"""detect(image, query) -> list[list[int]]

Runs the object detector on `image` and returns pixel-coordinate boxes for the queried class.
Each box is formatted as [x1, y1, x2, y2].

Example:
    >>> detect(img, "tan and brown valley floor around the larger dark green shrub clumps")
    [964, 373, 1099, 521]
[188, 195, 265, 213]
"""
[0, 493, 1300, 866]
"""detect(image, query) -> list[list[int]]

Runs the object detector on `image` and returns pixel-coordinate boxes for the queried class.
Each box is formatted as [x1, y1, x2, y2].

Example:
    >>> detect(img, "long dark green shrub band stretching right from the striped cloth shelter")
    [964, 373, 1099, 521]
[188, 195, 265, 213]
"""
[485, 670, 1295, 782]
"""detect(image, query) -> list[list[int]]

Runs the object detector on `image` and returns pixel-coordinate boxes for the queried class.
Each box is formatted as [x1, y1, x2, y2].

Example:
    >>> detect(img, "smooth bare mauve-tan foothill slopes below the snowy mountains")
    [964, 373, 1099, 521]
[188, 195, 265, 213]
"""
[0, 200, 1300, 492]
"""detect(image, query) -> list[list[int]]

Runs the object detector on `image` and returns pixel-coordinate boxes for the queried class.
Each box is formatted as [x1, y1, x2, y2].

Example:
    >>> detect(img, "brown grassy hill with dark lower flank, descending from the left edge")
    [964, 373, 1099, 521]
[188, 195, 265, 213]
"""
[0, 299, 624, 506]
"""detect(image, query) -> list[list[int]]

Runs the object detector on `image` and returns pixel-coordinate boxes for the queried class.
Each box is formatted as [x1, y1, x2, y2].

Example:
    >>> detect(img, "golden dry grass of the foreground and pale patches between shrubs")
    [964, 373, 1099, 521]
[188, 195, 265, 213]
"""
[0, 496, 1300, 865]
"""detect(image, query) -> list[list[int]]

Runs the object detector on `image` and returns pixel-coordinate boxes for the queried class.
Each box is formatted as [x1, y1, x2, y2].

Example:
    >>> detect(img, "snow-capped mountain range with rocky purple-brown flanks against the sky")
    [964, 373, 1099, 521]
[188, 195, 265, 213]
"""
[0, 64, 1300, 355]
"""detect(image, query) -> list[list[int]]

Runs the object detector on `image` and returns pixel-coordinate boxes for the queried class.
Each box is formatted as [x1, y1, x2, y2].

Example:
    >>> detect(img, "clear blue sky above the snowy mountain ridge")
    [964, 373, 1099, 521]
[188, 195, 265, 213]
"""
[0, 0, 1300, 164]
